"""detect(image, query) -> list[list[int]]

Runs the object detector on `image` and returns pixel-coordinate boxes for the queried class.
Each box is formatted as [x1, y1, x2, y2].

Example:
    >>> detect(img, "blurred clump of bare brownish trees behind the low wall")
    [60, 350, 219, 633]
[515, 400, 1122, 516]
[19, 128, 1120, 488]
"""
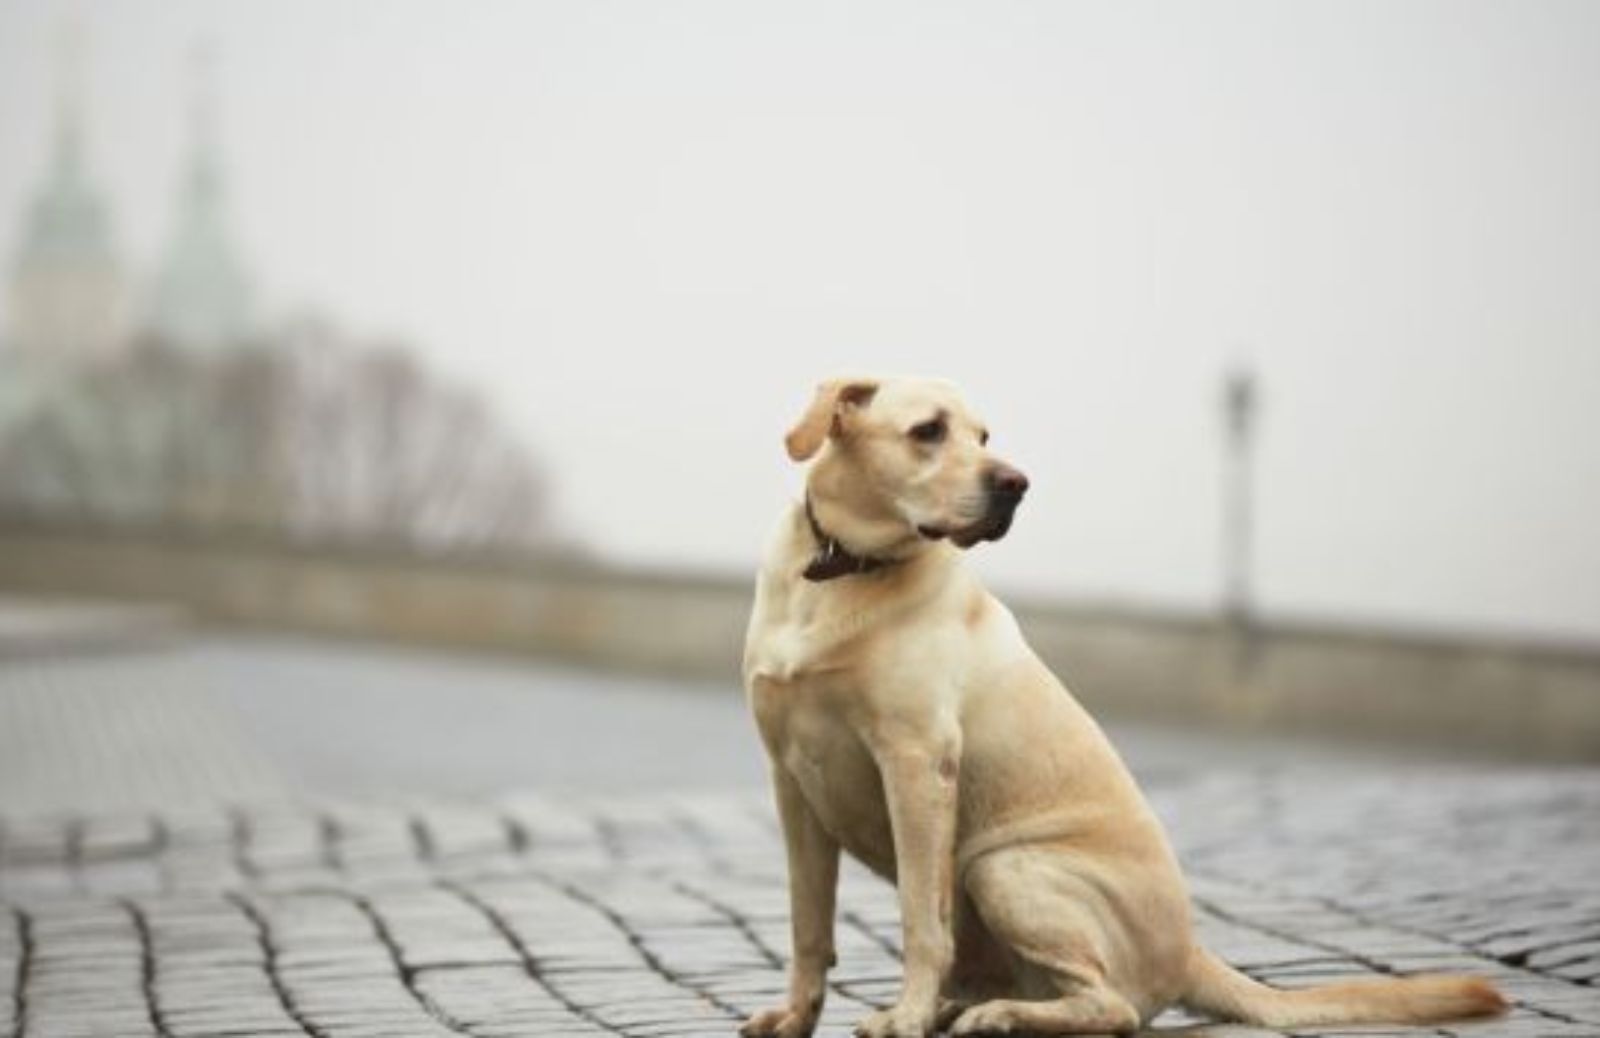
[0, 323, 549, 550]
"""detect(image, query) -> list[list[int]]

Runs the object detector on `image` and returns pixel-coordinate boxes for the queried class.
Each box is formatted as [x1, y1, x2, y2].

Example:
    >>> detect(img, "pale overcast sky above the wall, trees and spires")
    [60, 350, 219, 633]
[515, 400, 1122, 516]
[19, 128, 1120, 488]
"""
[0, 0, 1600, 641]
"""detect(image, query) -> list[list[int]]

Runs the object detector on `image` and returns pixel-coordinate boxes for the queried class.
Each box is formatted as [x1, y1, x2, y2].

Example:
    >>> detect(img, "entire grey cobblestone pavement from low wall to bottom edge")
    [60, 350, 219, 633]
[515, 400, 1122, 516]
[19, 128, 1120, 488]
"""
[0, 626, 1600, 1038]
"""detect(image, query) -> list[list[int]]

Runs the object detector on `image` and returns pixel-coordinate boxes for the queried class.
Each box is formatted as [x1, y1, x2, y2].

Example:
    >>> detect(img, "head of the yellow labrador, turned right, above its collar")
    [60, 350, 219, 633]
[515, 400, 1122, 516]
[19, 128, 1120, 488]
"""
[784, 377, 1027, 552]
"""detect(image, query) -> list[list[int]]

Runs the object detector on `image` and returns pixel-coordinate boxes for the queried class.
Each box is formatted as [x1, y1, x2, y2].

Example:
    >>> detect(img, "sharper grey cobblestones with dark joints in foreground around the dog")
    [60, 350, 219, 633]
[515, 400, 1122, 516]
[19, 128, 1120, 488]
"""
[0, 768, 1600, 1038]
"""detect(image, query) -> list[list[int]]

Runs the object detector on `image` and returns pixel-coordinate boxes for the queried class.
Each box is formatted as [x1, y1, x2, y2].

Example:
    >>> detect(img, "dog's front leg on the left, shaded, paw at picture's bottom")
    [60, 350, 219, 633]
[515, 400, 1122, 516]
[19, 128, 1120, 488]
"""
[739, 763, 838, 1038]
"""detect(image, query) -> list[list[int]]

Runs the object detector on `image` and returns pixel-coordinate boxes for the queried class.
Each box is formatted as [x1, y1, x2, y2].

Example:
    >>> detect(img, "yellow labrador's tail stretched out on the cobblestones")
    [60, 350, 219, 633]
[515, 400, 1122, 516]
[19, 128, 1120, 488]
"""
[1179, 945, 1509, 1028]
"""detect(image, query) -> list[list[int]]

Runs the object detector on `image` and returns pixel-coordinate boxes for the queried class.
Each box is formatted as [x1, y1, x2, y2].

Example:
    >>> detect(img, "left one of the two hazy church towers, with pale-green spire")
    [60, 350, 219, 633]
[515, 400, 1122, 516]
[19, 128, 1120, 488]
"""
[6, 17, 126, 369]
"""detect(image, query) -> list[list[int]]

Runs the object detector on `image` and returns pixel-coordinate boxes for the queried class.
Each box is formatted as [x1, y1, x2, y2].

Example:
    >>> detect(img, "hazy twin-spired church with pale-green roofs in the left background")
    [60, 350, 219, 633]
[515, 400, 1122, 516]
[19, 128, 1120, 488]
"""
[0, 24, 259, 517]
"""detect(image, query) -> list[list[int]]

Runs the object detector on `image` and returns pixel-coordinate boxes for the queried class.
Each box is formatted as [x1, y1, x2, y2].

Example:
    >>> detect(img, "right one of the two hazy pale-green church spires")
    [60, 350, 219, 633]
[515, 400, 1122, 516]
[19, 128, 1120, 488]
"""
[147, 50, 251, 353]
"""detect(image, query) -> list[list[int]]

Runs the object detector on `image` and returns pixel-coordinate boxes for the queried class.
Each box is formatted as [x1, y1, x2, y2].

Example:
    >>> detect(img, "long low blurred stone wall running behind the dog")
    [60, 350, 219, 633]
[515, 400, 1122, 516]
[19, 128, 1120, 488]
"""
[0, 525, 1600, 760]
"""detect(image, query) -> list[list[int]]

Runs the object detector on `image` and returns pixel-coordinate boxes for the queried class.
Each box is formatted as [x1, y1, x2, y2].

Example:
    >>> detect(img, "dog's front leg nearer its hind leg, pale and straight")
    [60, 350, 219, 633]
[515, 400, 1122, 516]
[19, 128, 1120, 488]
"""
[856, 725, 962, 1038]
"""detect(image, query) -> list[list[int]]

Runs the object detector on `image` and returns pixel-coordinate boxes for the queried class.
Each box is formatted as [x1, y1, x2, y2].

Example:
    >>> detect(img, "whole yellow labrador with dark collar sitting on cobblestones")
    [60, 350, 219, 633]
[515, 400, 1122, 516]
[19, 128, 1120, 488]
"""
[741, 379, 1506, 1038]
